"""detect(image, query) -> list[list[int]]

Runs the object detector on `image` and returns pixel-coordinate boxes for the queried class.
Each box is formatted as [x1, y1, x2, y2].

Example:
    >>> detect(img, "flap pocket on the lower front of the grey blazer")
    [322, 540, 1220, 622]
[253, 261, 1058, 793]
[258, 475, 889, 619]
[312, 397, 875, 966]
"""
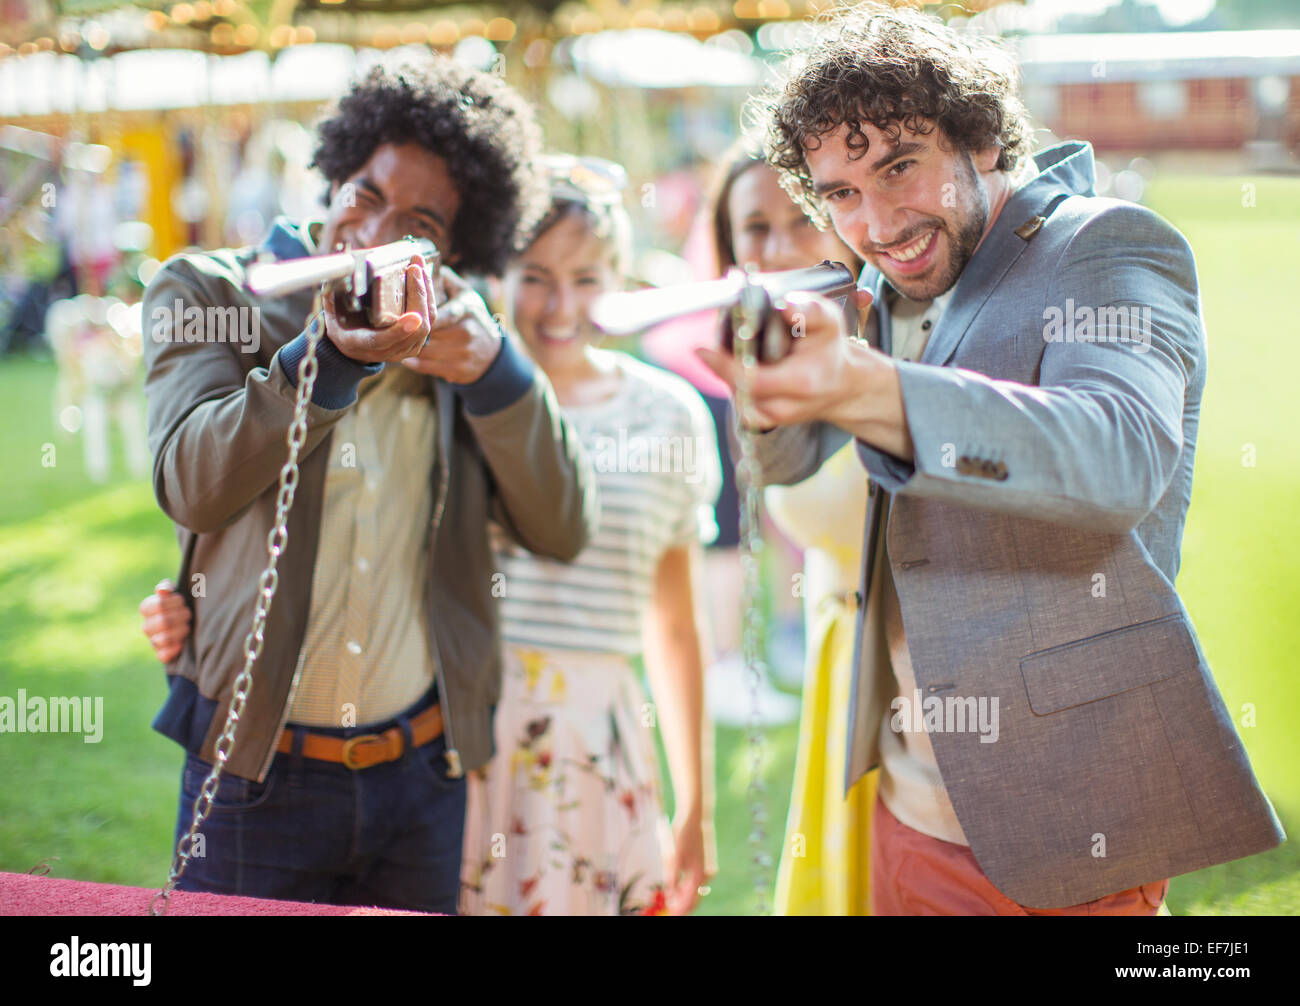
[1021, 612, 1200, 716]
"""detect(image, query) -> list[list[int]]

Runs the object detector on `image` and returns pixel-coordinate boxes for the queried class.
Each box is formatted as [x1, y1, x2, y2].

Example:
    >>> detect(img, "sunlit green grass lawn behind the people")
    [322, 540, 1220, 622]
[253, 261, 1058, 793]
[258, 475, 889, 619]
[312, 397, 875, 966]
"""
[0, 177, 1300, 915]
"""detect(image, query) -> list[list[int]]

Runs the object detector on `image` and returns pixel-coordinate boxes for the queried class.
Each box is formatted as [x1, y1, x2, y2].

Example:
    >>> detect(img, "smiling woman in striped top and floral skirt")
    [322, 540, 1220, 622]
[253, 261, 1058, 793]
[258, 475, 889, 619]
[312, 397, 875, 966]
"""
[462, 157, 720, 915]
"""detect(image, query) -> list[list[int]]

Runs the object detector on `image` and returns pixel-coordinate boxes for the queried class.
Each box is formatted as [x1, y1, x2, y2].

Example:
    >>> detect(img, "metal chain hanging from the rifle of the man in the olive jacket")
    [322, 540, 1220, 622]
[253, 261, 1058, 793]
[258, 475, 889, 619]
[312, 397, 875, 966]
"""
[150, 313, 324, 916]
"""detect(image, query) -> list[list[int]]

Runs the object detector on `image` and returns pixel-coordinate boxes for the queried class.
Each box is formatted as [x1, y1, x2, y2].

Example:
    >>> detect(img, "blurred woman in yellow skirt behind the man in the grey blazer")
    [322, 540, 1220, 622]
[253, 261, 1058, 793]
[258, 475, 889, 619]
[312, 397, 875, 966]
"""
[712, 131, 879, 915]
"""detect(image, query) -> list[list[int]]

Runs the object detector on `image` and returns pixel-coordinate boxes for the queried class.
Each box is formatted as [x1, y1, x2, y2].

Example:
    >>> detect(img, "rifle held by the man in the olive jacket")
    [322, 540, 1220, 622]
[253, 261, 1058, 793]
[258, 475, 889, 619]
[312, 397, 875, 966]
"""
[244, 238, 447, 329]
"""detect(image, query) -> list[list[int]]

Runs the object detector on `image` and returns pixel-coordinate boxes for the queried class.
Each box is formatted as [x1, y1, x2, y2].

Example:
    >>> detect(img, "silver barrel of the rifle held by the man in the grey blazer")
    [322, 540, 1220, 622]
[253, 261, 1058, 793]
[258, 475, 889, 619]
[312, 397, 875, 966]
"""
[592, 263, 854, 335]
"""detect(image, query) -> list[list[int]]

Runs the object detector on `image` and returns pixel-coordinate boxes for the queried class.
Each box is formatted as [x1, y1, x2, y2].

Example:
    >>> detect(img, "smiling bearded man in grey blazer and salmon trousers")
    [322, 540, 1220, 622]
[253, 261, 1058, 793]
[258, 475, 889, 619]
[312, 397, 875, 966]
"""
[701, 4, 1284, 915]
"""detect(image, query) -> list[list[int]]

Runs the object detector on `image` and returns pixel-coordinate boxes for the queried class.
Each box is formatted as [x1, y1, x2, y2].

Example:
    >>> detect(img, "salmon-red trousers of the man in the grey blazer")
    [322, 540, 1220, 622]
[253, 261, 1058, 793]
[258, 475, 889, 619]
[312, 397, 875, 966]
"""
[868, 795, 1169, 915]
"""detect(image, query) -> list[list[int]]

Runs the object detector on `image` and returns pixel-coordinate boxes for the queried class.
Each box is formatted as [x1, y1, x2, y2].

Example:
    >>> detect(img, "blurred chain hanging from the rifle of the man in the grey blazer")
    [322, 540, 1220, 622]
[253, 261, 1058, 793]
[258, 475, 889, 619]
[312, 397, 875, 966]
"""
[733, 279, 772, 915]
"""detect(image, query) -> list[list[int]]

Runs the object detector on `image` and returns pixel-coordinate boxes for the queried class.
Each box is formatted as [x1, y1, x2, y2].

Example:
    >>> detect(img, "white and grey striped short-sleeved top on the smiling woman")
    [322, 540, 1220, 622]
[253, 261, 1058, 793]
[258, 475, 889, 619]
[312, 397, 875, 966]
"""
[493, 350, 722, 655]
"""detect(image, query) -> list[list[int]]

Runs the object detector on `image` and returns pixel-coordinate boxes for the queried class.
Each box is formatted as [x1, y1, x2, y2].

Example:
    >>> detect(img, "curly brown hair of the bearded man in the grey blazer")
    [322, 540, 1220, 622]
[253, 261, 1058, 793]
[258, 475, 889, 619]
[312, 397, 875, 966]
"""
[746, 3, 1031, 227]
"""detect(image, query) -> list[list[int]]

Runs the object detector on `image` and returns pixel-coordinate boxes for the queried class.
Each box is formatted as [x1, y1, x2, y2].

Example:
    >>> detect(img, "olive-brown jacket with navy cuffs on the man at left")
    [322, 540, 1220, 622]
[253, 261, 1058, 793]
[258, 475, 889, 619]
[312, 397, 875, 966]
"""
[144, 221, 598, 780]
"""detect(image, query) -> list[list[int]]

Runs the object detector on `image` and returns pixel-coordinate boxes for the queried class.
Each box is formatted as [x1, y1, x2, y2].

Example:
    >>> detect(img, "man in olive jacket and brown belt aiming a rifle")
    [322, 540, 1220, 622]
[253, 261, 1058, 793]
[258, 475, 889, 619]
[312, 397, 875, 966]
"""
[142, 60, 595, 912]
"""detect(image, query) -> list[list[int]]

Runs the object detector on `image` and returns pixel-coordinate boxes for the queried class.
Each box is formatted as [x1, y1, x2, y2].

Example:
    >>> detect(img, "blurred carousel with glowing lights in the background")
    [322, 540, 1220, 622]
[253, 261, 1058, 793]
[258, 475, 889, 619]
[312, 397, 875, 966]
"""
[0, 0, 873, 283]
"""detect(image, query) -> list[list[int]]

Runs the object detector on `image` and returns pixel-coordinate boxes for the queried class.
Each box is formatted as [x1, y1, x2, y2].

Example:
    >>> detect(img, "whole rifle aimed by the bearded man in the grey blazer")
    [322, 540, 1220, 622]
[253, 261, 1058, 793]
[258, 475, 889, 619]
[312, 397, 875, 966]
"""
[592, 261, 858, 363]
